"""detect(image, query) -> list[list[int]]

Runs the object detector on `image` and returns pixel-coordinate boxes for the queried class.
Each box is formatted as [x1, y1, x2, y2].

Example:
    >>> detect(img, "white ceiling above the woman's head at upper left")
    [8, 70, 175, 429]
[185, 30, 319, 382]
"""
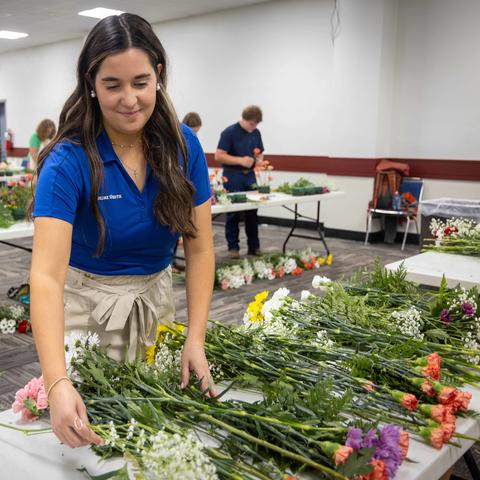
[0, 0, 269, 53]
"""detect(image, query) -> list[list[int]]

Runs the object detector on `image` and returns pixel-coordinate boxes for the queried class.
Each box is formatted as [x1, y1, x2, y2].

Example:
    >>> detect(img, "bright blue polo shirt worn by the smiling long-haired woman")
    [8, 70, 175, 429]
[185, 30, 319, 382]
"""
[33, 125, 211, 275]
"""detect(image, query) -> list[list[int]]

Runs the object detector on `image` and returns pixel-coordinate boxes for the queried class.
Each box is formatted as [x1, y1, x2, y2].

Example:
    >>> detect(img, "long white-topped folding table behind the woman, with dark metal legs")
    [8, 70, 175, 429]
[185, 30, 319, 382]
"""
[0, 191, 345, 254]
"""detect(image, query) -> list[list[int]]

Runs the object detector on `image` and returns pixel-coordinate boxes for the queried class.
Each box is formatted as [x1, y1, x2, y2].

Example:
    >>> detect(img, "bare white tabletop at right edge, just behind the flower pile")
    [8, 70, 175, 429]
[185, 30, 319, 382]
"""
[385, 251, 480, 288]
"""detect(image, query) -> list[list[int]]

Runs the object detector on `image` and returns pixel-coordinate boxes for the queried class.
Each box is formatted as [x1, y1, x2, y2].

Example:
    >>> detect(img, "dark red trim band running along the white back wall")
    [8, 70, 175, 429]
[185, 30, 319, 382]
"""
[206, 153, 480, 182]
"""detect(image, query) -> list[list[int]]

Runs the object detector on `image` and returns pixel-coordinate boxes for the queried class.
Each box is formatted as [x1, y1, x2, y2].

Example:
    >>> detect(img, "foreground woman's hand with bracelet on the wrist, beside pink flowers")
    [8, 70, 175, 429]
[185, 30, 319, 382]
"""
[49, 381, 103, 448]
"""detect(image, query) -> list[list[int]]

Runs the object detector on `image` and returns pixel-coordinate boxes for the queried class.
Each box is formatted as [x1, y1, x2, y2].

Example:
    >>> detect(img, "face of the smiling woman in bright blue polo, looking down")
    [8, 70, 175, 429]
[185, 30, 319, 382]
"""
[95, 48, 161, 135]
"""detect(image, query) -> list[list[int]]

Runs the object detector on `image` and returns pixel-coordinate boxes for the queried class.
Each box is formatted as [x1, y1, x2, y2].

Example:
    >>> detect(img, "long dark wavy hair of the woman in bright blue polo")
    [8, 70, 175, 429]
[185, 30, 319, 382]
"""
[29, 13, 196, 255]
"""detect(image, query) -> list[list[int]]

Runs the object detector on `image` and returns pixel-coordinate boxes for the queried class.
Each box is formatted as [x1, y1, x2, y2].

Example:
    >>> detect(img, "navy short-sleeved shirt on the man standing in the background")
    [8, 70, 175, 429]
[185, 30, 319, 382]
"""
[217, 122, 264, 170]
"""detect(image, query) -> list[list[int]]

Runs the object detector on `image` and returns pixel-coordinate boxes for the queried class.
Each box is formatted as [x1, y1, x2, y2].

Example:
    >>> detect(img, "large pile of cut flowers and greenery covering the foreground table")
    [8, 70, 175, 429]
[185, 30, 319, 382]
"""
[7, 264, 480, 480]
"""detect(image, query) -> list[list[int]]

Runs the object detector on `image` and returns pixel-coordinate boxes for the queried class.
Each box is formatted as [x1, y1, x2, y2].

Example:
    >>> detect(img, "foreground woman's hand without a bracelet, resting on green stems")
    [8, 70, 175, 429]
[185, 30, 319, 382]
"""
[180, 337, 217, 397]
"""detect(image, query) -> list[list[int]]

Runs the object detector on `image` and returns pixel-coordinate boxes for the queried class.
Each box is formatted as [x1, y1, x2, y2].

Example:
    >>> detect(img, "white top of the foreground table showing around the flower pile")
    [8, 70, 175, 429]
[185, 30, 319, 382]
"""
[0, 387, 480, 480]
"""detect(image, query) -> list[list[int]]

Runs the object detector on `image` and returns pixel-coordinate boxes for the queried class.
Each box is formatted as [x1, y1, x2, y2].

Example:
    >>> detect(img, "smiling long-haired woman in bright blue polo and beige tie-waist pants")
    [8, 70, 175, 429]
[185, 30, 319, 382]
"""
[26, 14, 215, 447]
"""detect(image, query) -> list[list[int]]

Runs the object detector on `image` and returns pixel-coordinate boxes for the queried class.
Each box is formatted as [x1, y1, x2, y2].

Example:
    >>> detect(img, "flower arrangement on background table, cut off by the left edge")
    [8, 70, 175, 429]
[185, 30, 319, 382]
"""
[0, 174, 33, 228]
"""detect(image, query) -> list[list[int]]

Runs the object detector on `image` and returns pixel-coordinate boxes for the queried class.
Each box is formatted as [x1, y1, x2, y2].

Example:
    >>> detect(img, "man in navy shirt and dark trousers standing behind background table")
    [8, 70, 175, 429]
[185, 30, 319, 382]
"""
[215, 105, 264, 258]
